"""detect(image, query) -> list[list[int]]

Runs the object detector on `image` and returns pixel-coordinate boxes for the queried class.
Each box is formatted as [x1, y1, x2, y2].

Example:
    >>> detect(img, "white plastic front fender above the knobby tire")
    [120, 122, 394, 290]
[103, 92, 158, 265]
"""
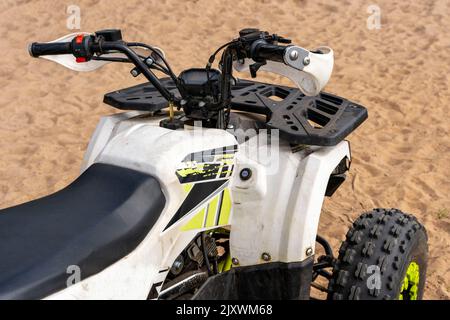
[230, 139, 350, 266]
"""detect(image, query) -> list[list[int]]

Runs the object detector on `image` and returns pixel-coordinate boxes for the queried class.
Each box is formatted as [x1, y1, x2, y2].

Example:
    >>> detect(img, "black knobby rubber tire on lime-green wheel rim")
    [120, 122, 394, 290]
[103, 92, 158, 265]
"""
[328, 209, 428, 300]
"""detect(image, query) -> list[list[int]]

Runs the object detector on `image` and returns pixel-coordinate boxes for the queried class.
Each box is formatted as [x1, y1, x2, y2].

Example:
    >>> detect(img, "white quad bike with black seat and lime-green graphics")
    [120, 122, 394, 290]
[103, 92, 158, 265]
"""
[0, 29, 427, 300]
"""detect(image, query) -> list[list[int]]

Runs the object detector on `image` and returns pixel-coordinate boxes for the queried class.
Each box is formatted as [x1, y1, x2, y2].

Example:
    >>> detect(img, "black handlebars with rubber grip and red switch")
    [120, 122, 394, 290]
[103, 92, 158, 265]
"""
[28, 29, 312, 120]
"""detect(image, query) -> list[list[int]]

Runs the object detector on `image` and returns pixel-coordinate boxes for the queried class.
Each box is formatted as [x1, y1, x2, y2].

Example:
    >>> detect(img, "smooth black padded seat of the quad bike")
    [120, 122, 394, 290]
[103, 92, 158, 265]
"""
[0, 164, 165, 299]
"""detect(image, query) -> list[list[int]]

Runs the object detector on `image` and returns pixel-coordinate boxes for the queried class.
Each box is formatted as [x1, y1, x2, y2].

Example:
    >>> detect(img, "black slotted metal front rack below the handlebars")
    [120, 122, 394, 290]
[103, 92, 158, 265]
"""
[104, 78, 368, 146]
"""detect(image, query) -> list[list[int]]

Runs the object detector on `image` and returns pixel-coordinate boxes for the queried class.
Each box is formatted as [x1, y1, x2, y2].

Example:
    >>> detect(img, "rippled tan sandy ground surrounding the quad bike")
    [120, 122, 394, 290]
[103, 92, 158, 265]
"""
[0, 0, 450, 299]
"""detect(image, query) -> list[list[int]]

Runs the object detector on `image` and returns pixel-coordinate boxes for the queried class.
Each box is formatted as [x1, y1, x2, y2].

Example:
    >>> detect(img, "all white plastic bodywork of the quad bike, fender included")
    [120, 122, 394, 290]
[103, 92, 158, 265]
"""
[47, 111, 350, 299]
